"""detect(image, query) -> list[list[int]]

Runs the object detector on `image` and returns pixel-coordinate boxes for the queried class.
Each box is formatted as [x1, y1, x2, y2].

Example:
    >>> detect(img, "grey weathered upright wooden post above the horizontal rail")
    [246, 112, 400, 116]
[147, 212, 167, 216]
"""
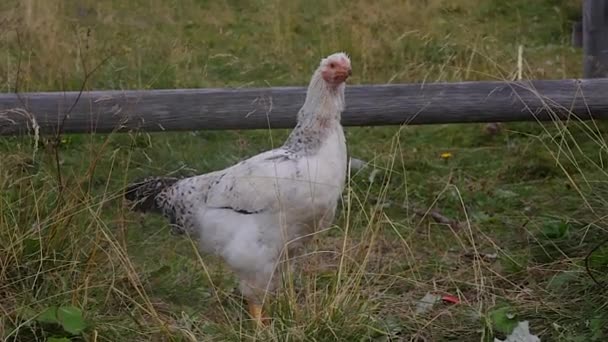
[583, 0, 608, 78]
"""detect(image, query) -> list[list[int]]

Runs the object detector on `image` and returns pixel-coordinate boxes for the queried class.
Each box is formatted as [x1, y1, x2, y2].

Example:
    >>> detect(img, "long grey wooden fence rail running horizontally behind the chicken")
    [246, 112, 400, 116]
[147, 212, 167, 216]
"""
[0, 78, 608, 135]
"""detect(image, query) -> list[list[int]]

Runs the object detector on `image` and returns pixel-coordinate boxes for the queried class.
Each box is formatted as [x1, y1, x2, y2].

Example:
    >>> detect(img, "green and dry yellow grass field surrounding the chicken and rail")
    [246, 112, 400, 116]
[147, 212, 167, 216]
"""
[0, 0, 608, 341]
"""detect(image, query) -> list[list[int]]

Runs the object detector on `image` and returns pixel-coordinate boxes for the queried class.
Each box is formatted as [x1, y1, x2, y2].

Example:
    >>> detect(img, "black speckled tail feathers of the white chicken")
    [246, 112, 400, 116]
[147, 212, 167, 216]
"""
[125, 177, 179, 212]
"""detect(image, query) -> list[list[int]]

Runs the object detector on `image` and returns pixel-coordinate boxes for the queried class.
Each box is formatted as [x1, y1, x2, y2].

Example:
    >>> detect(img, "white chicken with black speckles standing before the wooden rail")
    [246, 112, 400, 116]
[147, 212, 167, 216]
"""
[125, 53, 351, 323]
